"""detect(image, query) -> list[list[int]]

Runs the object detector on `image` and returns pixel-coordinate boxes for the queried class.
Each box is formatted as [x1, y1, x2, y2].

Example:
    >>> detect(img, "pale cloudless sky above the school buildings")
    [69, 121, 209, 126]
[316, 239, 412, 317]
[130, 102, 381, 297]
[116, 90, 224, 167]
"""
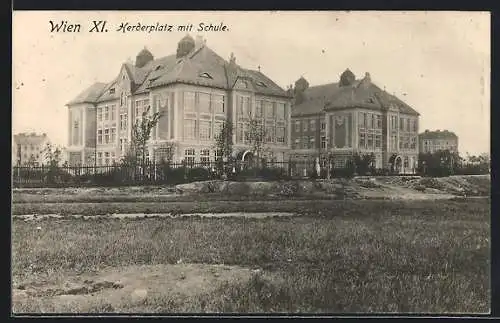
[12, 11, 490, 154]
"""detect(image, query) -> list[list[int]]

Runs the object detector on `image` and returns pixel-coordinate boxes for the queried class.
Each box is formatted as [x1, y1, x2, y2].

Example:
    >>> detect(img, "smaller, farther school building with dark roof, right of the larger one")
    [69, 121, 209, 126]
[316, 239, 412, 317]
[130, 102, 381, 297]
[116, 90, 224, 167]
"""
[289, 69, 419, 173]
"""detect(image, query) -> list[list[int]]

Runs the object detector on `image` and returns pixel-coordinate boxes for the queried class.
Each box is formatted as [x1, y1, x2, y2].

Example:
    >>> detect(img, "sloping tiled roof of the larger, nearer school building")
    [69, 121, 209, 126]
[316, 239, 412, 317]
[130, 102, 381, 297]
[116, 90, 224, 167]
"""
[68, 40, 288, 104]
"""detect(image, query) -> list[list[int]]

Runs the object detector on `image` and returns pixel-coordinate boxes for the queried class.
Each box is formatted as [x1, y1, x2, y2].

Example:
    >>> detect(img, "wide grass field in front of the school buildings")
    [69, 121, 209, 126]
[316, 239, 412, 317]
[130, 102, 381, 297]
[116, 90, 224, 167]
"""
[12, 199, 490, 313]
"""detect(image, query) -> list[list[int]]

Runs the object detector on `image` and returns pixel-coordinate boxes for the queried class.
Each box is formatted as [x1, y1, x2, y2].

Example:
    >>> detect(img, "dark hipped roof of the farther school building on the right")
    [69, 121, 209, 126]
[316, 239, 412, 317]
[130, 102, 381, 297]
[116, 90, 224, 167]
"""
[292, 79, 420, 116]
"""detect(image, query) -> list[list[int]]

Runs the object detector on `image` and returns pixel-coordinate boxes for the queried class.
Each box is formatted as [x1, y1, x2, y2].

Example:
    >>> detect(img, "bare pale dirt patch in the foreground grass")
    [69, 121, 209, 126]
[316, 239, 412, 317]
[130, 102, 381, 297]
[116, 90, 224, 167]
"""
[12, 264, 262, 313]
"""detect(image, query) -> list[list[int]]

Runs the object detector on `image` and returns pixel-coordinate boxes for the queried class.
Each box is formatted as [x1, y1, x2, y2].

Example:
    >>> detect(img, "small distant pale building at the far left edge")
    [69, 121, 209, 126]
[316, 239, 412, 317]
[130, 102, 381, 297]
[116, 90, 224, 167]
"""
[12, 133, 49, 166]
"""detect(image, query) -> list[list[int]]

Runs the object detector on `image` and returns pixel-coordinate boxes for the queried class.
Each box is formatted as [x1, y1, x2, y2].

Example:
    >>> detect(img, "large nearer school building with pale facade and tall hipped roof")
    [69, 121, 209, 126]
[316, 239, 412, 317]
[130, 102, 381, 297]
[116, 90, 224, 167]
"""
[67, 35, 291, 165]
